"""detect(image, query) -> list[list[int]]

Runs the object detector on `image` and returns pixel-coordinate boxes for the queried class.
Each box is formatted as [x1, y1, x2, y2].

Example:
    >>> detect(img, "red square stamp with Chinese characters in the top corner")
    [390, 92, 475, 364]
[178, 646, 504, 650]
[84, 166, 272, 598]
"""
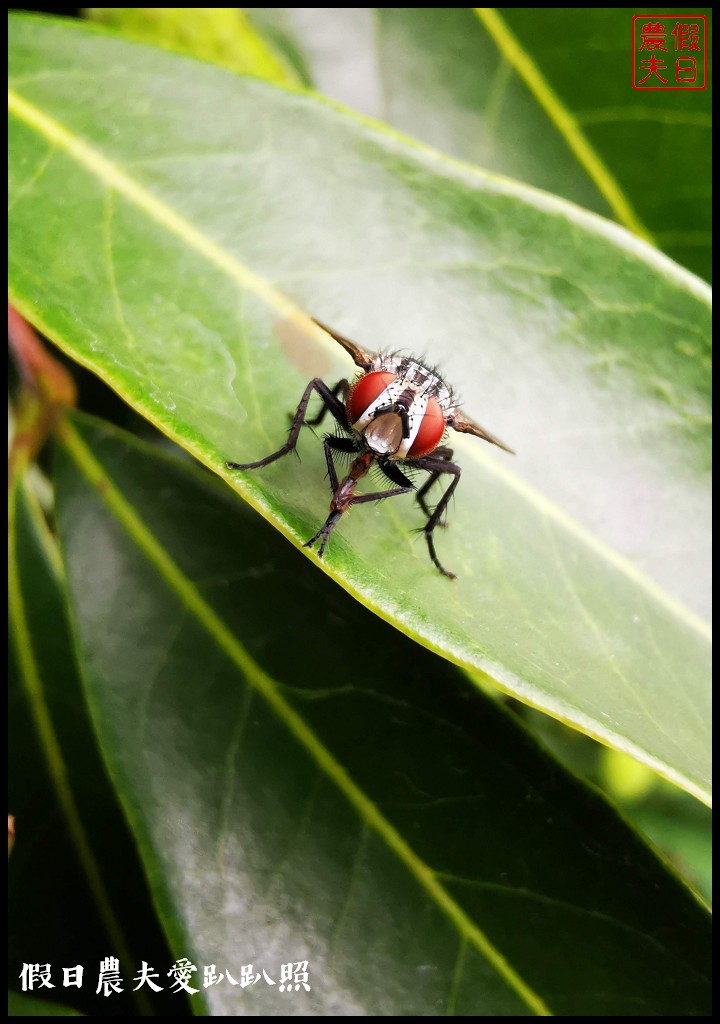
[632, 14, 708, 89]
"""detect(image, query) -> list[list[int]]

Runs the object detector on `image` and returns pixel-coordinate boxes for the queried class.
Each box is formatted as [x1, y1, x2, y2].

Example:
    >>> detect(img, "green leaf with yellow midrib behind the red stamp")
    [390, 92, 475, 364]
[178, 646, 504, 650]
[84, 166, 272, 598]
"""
[251, 7, 712, 278]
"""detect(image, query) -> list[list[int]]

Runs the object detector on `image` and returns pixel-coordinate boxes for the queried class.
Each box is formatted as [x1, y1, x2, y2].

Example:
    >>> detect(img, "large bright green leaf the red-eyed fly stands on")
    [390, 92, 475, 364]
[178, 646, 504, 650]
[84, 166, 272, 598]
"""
[9, 16, 710, 800]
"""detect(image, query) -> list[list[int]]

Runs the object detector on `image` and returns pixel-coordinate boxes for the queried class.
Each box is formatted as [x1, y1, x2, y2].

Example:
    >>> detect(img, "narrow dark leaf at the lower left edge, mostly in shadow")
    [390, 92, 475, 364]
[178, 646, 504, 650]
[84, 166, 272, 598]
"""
[8, 481, 183, 1016]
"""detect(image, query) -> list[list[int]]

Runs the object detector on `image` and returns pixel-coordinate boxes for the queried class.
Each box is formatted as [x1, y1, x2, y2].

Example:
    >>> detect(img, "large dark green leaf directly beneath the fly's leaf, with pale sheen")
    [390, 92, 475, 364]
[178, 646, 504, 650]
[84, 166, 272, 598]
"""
[56, 418, 709, 1016]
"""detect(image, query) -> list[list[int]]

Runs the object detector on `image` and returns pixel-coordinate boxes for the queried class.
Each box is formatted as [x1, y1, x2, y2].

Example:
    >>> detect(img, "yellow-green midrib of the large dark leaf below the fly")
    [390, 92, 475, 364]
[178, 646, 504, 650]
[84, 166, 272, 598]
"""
[59, 421, 554, 1017]
